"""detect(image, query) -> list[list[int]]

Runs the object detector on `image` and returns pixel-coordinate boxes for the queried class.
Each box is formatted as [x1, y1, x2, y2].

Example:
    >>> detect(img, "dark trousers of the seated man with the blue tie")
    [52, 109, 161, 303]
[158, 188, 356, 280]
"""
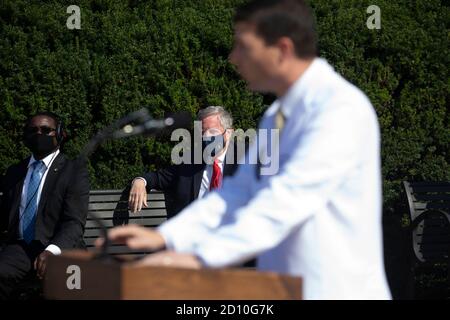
[0, 241, 44, 300]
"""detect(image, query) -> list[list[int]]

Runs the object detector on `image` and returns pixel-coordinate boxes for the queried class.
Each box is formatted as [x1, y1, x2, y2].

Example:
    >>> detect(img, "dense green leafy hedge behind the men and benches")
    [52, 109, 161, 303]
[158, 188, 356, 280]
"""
[0, 0, 450, 215]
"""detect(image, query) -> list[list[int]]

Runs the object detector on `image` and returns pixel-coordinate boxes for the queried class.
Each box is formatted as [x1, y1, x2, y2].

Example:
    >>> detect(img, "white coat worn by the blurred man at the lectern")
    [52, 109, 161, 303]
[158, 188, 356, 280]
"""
[159, 58, 391, 299]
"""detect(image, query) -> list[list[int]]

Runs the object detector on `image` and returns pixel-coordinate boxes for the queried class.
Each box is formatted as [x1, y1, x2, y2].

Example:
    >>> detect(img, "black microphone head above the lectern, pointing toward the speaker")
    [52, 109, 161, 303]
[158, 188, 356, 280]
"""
[112, 111, 192, 139]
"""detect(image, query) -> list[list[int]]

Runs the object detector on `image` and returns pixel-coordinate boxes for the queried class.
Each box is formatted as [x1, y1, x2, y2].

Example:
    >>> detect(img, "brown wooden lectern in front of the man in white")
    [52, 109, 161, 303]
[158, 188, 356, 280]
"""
[44, 250, 302, 300]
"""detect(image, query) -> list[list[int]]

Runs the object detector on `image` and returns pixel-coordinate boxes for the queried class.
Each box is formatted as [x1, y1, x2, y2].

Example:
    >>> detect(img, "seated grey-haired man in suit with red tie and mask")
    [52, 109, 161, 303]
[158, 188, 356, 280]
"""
[129, 106, 237, 218]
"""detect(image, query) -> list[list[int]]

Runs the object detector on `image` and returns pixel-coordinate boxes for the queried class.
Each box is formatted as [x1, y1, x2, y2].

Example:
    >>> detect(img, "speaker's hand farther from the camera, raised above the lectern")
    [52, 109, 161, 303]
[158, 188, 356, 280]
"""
[95, 224, 166, 250]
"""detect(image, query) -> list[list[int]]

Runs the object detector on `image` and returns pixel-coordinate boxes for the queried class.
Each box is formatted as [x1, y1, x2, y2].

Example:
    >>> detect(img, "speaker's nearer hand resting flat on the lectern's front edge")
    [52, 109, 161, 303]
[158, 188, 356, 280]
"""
[133, 251, 202, 269]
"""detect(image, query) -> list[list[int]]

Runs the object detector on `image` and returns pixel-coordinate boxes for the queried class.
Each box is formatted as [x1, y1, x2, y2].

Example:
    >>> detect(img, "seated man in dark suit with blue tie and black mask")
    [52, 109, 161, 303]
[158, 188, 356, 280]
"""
[0, 112, 89, 299]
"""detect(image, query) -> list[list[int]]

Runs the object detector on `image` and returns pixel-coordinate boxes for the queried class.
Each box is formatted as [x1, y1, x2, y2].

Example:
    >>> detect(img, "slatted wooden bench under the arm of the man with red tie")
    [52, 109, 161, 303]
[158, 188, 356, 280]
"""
[83, 189, 167, 256]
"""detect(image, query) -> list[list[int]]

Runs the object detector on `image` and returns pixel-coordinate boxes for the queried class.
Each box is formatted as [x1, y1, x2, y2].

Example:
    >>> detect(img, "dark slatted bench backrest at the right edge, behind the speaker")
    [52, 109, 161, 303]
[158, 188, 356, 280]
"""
[403, 181, 450, 262]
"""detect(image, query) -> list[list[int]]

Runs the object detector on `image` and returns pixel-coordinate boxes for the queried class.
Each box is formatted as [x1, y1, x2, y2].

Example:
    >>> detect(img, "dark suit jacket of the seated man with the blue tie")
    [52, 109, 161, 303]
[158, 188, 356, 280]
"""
[0, 153, 89, 249]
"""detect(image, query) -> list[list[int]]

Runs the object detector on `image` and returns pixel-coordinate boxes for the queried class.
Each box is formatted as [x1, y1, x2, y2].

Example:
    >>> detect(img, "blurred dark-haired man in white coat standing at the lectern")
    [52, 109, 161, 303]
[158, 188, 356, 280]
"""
[98, 0, 391, 299]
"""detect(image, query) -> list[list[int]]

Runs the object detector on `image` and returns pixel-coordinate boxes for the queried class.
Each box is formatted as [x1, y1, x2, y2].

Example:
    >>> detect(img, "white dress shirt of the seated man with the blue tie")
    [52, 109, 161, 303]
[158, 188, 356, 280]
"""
[19, 149, 61, 255]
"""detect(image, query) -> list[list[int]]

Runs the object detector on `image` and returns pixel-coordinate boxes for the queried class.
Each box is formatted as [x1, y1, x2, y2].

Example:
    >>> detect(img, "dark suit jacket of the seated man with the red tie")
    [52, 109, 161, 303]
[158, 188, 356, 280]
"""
[142, 146, 243, 218]
